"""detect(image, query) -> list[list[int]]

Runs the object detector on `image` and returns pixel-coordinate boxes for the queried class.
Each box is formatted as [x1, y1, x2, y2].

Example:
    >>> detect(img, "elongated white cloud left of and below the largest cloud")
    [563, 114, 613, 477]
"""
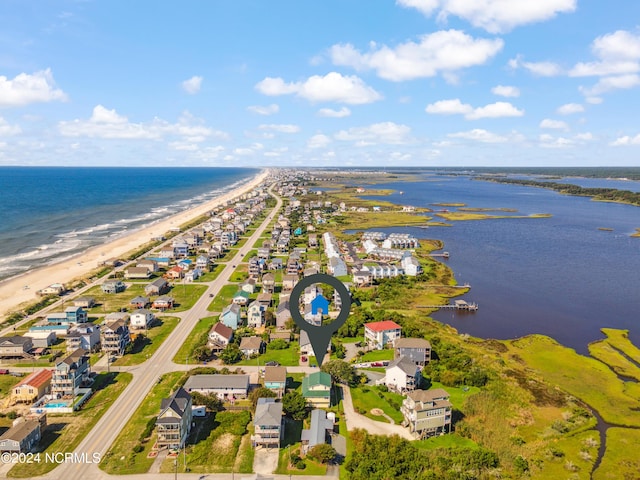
[255, 72, 382, 105]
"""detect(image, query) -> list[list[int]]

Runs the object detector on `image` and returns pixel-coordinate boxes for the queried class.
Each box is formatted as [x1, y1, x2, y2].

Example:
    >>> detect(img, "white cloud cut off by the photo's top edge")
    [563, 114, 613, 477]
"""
[396, 0, 577, 33]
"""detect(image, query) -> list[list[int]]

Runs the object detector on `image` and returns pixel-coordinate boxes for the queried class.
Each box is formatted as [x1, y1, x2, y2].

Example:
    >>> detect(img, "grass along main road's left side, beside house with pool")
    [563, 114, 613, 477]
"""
[7, 372, 133, 478]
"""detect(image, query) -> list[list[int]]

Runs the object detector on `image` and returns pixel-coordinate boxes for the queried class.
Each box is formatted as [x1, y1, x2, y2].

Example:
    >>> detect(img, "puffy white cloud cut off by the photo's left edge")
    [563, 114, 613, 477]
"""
[0, 69, 67, 108]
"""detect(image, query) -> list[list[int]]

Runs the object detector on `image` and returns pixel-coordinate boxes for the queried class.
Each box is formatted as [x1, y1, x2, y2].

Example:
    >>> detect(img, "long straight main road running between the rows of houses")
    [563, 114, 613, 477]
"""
[46, 183, 282, 480]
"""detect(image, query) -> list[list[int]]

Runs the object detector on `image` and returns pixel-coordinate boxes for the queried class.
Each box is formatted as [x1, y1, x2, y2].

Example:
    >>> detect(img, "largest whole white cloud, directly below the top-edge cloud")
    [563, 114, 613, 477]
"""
[329, 30, 504, 82]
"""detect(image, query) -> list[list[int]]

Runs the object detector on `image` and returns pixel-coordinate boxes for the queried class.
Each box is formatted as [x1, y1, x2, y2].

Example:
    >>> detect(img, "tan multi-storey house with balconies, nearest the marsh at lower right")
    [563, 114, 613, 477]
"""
[400, 388, 452, 437]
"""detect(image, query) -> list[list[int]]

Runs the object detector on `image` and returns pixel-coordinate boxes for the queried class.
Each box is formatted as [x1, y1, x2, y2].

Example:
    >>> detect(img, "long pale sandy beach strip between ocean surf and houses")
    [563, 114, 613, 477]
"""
[0, 170, 269, 317]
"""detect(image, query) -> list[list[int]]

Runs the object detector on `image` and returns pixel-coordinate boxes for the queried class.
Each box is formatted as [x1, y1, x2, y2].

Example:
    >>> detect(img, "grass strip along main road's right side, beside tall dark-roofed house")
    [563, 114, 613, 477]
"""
[100, 372, 185, 475]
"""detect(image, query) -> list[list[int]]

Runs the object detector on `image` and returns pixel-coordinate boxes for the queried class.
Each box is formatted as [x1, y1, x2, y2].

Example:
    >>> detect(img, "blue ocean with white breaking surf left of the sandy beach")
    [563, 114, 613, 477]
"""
[0, 167, 258, 280]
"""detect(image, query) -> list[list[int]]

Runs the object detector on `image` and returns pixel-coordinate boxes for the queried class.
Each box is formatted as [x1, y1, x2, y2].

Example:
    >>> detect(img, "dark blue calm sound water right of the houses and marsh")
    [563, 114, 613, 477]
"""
[360, 171, 640, 353]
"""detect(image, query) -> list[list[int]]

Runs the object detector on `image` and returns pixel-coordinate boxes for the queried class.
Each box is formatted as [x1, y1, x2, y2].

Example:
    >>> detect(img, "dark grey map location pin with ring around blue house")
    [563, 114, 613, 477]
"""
[289, 273, 351, 367]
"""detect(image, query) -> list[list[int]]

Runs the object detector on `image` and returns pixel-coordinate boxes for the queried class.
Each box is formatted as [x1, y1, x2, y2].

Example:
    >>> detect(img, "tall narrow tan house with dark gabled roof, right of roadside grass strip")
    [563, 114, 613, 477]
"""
[156, 388, 192, 450]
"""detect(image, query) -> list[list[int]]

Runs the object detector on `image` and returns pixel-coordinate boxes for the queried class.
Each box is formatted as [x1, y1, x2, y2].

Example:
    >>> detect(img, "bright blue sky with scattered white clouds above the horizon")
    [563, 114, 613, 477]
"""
[0, 0, 640, 166]
